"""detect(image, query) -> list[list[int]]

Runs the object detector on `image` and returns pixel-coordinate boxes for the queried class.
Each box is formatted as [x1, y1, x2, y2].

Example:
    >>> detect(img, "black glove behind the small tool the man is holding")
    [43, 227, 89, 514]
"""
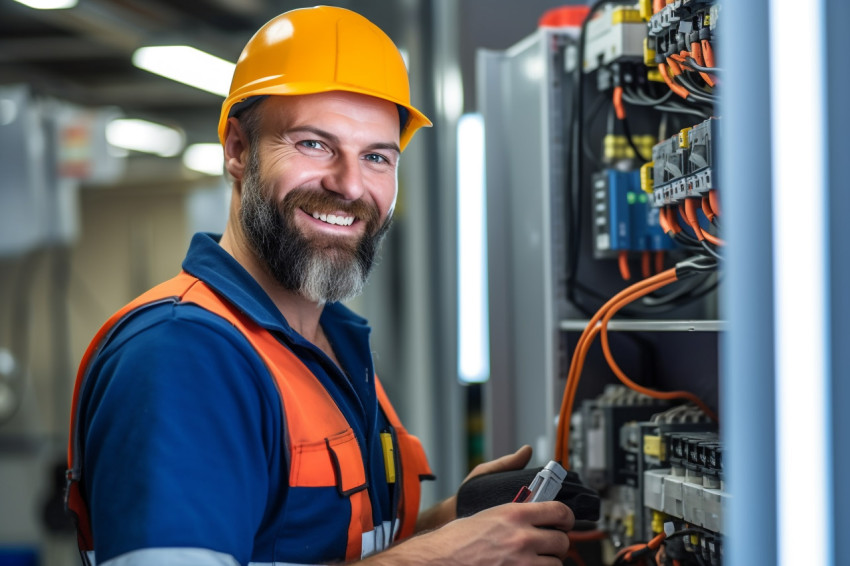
[457, 466, 599, 521]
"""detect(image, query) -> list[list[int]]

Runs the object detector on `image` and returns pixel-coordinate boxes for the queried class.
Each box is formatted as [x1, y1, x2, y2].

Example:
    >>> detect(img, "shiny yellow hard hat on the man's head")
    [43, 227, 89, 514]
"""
[218, 6, 431, 149]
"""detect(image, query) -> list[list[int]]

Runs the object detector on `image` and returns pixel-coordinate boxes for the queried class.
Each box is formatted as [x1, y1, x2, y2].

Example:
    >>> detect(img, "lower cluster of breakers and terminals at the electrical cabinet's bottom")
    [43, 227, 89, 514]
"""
[571, 385, 729, 564]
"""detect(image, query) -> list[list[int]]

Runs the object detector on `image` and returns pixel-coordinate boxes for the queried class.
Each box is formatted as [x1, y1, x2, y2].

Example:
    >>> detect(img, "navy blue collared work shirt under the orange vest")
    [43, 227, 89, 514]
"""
[79, 234, 393, 564]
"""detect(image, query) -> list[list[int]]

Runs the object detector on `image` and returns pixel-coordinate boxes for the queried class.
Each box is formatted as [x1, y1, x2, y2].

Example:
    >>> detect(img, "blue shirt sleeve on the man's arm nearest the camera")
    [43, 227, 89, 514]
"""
[81, 305, 282, 564]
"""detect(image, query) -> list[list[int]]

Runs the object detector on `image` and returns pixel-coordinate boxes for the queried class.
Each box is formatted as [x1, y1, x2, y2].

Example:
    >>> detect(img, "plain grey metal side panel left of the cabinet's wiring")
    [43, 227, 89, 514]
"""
[478, 29, 563, 462]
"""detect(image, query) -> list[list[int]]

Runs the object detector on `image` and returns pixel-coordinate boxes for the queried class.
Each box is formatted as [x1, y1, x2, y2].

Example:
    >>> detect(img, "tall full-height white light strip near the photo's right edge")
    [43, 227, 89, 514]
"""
[768, 0, 833, 566]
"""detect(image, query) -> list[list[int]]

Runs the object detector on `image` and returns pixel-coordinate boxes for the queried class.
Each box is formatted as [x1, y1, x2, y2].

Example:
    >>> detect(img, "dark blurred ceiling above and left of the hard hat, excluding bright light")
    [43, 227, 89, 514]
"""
[0, 0, 408, 149]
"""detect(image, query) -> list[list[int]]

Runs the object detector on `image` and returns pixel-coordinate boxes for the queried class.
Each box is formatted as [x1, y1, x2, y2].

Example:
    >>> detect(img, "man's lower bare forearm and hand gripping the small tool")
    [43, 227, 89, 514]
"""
[365, 501, 575, 566]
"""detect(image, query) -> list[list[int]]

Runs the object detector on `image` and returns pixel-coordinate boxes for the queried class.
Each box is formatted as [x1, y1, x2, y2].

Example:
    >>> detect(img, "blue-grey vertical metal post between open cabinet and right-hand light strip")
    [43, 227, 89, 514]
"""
[718, 0, 776, 566]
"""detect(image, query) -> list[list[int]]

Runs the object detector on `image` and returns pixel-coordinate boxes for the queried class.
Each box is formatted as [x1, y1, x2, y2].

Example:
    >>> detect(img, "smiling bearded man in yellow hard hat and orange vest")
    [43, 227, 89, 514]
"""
[68, 7, 574, 566]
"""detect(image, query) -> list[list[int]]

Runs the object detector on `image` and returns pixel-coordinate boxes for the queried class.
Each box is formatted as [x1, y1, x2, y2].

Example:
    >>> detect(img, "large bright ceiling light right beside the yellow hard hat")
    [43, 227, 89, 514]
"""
[133, 45, 236, 96]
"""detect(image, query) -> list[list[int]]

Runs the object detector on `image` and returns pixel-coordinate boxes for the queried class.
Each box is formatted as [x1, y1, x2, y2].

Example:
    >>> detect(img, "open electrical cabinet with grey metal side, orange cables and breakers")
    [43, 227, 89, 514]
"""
[477, 0, 716, 566]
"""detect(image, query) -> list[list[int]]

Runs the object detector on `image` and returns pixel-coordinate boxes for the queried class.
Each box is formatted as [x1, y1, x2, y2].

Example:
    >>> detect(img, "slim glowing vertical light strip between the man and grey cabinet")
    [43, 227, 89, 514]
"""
[457, 114, 490, 383]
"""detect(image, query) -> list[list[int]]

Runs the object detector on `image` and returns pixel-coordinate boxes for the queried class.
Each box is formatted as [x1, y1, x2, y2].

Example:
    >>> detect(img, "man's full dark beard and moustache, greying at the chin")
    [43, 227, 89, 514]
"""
[241, 147, 392, 304]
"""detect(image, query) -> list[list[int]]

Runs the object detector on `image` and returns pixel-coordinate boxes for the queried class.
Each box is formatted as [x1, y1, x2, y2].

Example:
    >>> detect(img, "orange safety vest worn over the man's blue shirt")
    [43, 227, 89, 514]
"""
[66, 271, 433, 560]
